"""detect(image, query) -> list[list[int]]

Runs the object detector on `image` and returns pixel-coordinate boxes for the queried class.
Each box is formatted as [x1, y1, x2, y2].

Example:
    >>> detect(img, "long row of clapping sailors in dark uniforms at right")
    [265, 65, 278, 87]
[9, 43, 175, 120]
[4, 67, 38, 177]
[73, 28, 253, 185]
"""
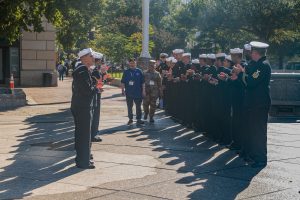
[157, 42, 271, 167]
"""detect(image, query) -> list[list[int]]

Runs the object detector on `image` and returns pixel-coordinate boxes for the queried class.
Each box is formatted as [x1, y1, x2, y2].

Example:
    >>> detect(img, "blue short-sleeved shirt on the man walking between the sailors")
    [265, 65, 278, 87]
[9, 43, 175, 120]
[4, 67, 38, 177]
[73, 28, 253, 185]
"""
[121, 68, 145, 99]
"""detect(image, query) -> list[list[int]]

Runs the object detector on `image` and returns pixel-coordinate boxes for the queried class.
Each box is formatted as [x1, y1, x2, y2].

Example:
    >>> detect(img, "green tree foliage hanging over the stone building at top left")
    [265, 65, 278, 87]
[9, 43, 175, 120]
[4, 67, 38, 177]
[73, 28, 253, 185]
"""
[0, 0, 102, 50]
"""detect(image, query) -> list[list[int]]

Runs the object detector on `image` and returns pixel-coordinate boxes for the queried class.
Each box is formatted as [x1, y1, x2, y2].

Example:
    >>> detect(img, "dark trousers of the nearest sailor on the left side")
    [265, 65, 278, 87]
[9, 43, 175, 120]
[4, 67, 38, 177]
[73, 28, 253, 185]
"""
[71, 108, 92, 167]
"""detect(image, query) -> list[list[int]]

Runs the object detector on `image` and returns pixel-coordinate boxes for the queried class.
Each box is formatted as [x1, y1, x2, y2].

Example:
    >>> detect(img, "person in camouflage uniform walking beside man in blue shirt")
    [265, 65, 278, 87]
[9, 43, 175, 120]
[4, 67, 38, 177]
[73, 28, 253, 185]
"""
[143, 60, 162, 123]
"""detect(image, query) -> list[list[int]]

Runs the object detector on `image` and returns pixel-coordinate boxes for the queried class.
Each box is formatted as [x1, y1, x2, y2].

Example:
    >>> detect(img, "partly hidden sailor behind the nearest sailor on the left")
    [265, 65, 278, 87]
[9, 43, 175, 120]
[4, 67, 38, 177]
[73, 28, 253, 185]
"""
[91, 52, 103, 142]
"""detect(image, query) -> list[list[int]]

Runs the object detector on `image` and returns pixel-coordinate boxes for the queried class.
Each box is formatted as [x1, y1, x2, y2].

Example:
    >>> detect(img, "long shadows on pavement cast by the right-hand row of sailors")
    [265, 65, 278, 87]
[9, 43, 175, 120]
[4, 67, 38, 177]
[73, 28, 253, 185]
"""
[124, 113, 262, 200]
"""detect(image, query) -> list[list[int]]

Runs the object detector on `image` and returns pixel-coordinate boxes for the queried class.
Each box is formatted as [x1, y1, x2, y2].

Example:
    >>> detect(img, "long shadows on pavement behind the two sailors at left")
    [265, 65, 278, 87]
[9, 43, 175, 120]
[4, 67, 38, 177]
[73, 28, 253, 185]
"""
[0, 109, 81, 199]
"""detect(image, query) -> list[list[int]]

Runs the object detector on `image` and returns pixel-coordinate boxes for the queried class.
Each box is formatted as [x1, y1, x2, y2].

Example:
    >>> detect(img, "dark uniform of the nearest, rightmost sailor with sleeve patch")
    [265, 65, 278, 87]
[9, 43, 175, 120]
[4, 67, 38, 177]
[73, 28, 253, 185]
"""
[240, 57, 271, 163]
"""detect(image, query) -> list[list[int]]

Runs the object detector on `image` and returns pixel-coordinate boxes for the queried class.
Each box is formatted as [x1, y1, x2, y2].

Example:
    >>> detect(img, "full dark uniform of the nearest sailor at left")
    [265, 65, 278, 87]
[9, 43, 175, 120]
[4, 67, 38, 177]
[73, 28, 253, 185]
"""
[71, 64, 96, 168]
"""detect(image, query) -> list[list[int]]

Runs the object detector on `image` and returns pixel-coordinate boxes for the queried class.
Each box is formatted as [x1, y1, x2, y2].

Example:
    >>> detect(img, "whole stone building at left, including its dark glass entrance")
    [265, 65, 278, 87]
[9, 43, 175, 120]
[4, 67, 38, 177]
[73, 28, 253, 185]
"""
[0, 21, 57, 86]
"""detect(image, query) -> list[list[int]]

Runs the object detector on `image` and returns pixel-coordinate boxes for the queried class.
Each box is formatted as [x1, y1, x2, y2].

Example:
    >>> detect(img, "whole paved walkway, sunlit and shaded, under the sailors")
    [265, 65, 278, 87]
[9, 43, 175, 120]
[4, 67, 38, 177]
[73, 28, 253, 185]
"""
[0, 79, 300, 200]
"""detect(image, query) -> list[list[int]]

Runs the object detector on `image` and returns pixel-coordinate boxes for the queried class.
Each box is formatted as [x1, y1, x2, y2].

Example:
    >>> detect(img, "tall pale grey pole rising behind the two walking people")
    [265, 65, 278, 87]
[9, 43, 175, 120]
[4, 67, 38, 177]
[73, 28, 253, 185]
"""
[138, 0, 151, 69]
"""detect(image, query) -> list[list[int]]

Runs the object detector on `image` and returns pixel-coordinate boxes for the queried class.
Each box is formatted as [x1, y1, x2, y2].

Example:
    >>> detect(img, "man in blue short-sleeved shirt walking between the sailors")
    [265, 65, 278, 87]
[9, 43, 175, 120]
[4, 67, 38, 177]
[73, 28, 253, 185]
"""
[121, 58, 145, 125]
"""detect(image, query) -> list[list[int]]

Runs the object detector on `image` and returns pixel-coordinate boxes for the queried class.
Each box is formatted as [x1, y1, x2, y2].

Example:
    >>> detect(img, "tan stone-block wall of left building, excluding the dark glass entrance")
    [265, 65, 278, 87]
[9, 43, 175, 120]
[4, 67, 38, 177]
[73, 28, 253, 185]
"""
[20, 21, 57, 86]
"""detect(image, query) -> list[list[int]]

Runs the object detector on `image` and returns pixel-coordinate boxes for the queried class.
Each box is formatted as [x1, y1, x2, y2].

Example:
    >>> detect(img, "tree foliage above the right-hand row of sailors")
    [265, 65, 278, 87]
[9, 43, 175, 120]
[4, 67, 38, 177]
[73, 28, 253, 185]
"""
[176, 0, 300, 65]
